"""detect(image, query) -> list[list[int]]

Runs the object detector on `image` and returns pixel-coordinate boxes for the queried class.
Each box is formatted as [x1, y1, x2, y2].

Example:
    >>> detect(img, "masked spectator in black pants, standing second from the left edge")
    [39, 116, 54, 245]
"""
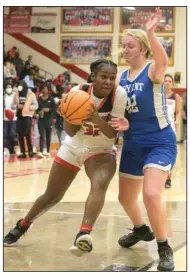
[15, 81, 38, 158]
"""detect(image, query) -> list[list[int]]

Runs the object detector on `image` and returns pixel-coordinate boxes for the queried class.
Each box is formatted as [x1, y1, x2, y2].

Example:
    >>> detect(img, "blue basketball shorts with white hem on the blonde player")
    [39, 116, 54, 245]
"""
[119, 126, 177, 179]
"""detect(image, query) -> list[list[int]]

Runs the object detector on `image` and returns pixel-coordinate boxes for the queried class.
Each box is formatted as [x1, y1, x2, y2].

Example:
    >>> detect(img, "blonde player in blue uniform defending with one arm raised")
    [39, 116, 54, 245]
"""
[111, 8, 177, 271]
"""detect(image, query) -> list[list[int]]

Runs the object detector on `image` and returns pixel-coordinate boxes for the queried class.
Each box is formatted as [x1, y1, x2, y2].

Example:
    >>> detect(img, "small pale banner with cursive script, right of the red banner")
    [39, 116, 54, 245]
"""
[31, 16, 56, 33]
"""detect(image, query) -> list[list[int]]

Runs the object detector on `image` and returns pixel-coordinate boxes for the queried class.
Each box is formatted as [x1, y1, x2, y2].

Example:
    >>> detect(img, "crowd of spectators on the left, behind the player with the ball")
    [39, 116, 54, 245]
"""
[3, 45, 78, 158]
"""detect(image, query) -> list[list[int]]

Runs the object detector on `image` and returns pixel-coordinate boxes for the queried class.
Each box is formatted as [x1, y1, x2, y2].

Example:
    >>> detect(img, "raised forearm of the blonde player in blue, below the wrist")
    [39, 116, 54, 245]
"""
[147, 32, 168, 67]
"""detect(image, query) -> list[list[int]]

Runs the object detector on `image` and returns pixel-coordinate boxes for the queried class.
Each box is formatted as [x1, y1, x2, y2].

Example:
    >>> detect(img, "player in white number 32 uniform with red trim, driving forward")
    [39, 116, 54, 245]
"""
[4, 59, 129, 256]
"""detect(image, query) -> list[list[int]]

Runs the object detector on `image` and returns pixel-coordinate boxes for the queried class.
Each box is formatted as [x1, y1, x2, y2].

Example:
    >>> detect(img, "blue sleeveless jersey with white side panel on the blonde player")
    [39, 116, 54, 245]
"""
[119, 63, 170, 136]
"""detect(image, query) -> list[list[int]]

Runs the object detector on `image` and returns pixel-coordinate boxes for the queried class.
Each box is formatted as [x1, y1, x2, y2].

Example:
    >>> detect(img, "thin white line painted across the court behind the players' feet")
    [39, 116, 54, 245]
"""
[4, 207, 186, 222]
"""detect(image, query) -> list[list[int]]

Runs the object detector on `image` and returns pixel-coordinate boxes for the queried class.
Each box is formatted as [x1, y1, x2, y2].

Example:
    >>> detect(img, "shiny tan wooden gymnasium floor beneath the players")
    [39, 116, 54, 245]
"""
[4, 144, 186, 271]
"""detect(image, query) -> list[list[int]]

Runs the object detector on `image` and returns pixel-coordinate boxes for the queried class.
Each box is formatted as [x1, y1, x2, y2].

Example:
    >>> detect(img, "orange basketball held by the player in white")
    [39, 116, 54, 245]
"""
[59, 90, 93, 125]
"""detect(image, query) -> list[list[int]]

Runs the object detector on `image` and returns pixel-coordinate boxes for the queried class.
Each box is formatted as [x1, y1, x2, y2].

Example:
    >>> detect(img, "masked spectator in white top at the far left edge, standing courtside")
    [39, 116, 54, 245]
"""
[3, 83, 19, 154]
